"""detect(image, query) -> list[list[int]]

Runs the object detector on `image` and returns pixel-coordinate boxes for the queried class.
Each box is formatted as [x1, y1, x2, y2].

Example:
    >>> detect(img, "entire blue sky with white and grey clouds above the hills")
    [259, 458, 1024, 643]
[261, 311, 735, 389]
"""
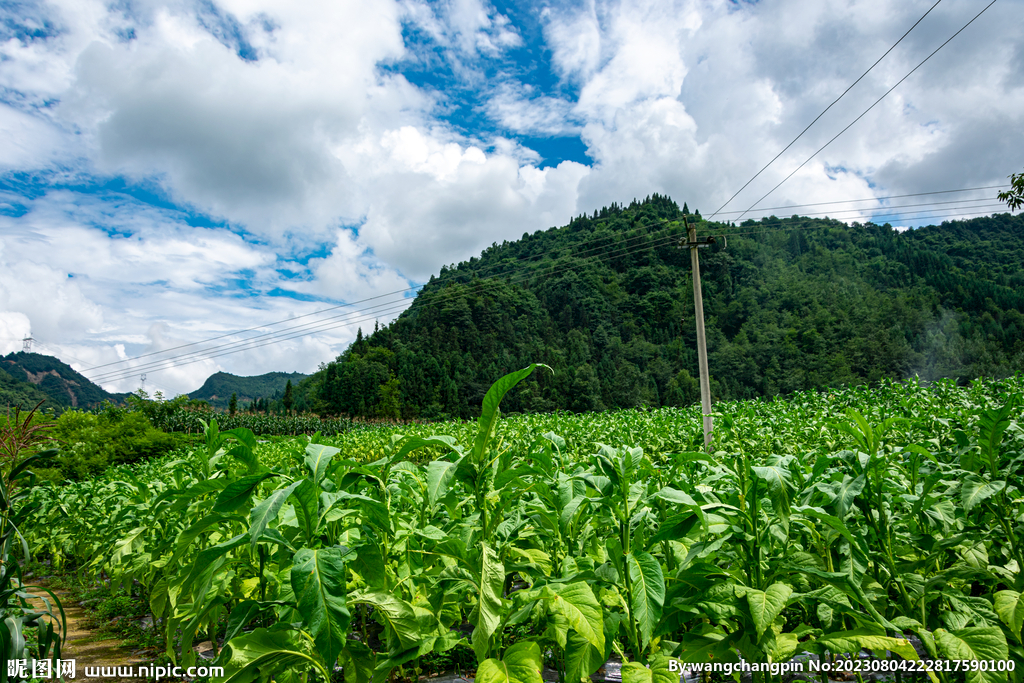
[0, 0, 1024, 395]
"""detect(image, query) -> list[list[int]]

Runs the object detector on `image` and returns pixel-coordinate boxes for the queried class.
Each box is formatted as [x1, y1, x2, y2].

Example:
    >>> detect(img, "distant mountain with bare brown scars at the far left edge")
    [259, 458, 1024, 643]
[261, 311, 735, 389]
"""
[0, 351, 127, 412]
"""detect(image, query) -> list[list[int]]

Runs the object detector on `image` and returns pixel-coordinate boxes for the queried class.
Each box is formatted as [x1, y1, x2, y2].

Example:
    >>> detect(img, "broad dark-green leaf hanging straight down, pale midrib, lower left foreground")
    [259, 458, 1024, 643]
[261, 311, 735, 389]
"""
[292, 547, 351, 666]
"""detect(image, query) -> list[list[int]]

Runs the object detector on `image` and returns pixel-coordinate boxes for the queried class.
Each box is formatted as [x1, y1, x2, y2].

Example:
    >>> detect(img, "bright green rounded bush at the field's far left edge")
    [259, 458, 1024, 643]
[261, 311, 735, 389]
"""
[45, 411, 177, 479]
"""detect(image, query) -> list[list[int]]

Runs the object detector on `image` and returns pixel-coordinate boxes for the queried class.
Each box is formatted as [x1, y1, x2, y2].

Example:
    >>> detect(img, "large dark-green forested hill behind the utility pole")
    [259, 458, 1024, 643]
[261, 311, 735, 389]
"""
[311, 195, 1024, 418]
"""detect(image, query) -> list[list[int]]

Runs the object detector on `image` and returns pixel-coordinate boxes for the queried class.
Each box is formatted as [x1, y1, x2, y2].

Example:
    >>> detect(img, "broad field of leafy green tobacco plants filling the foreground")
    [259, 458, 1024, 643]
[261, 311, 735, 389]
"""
[20, 366, 1024, 683]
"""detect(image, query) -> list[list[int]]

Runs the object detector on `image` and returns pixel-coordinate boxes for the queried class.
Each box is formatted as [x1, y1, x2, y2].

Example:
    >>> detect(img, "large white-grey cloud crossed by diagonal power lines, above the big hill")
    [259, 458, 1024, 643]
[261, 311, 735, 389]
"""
[546, 0, 1024, 214]
